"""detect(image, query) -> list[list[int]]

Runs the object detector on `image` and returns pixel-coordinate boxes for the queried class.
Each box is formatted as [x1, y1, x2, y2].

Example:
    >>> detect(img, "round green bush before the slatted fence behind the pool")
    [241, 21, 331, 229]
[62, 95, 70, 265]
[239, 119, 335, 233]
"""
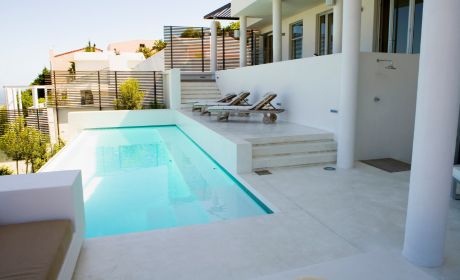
[115, 79, 144, 110]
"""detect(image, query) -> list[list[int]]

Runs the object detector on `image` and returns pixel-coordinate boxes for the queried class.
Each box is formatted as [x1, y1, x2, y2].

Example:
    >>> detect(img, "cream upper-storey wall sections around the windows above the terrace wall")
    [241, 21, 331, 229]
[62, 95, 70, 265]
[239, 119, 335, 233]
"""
[261, 0, 375, 60]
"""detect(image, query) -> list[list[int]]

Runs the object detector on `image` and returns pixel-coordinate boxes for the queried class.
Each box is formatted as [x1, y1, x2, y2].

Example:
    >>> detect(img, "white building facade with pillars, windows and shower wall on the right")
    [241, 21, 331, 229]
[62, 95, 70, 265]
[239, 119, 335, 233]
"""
[211, 0, 460, 267]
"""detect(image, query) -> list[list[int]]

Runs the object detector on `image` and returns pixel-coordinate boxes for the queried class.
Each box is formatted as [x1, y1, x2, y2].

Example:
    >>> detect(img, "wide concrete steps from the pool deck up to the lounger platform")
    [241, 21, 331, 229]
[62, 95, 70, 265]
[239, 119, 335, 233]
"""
[250, 133, 337, 169]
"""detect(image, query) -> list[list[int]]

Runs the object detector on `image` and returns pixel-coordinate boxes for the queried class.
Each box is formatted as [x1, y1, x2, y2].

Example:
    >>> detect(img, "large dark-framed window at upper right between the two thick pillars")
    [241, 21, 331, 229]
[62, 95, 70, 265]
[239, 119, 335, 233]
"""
[378, 0, 423, 53]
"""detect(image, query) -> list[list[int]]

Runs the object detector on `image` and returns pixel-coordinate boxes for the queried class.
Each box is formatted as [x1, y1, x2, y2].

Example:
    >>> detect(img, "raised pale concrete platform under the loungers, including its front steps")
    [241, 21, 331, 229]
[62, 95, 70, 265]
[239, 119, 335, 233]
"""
[181, 109, 337, 169]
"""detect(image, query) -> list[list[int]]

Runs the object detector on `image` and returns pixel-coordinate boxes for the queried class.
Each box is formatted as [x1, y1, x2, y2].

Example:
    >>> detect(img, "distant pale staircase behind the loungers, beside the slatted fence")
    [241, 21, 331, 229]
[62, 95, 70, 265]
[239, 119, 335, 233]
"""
[181, 81, 221, 104]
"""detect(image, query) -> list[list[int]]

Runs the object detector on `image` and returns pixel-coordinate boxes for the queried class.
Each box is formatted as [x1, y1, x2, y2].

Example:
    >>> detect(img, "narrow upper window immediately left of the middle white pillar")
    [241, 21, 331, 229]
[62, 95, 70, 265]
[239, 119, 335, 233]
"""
[316, 11, 334, 55]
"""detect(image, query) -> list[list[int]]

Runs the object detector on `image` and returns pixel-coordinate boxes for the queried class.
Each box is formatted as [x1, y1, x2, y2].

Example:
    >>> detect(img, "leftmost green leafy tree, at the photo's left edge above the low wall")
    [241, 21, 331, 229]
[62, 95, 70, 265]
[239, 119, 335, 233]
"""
[0, 118, 27, 174]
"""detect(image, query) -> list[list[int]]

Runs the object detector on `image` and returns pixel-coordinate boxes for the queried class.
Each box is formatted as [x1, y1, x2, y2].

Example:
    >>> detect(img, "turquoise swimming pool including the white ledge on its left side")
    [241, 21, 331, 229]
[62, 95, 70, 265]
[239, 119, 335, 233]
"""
[46, 126, 271, 238]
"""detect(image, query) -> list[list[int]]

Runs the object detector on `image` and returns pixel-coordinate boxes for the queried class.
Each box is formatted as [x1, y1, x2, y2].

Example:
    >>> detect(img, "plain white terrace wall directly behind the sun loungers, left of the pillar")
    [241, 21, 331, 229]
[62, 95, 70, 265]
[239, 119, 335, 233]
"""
[216, 55, 341, 132]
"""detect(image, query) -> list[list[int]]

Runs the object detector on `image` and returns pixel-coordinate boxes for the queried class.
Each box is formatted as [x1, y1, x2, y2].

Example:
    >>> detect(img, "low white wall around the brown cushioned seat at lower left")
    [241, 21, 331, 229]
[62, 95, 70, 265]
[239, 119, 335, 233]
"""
[0, 171, 85, 279]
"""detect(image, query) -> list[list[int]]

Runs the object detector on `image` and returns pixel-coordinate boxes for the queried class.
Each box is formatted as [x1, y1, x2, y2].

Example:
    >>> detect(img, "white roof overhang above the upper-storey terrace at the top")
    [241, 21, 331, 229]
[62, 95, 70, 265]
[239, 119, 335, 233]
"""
[232, 0, 325, 28]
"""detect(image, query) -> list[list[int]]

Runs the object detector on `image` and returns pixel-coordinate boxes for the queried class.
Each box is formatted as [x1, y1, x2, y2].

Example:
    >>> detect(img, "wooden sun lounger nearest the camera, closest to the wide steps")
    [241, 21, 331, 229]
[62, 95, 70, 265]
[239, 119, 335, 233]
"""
[207, 93, 284, 124]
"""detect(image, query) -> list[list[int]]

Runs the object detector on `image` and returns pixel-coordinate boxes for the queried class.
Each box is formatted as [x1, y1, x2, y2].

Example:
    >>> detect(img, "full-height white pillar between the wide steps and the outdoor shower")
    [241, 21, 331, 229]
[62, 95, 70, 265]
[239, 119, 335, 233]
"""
[337, 0, 361, 169]
